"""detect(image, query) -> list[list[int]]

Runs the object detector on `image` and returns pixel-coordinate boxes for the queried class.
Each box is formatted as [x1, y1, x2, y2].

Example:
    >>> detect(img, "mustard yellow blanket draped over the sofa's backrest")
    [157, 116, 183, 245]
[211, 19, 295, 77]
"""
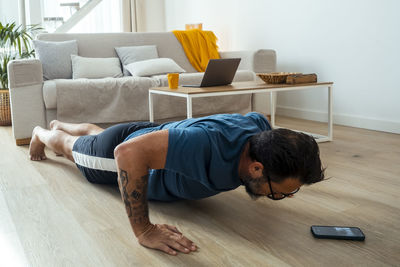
[173, 30, 220, 72]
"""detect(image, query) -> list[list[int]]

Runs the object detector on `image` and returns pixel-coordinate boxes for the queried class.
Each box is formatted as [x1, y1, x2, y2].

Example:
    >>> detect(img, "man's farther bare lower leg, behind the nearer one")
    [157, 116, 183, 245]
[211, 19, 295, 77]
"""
[50, 120, 104, 136]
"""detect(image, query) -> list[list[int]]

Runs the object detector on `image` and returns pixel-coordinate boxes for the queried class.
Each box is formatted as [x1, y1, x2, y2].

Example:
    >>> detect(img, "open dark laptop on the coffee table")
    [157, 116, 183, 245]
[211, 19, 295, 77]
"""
[182, 58, 240, 87]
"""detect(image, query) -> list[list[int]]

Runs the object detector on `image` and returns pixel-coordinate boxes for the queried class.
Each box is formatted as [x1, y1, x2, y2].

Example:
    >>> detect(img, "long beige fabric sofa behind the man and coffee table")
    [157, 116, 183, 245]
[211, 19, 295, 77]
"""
[8, 32, 276, 145]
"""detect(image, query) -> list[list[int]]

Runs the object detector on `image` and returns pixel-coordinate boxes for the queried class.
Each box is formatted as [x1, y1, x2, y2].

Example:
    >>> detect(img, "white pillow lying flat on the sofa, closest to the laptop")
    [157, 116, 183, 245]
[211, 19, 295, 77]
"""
[125, 58, 186, 76]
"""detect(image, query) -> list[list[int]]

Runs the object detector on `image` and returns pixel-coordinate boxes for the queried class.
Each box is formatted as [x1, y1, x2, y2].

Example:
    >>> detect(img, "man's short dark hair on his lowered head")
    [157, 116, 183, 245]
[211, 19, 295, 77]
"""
[249, 128, 325, 184]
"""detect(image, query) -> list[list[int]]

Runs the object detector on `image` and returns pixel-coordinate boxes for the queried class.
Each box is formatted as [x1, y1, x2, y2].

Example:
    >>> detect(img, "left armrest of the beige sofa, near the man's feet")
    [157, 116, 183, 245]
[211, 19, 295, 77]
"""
[8, 59, 46, 144]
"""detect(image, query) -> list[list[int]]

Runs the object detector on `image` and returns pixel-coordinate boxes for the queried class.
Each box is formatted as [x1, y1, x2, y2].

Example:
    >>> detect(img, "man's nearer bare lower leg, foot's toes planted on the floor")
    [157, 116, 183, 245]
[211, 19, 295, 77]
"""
[29, 126, 79, 162]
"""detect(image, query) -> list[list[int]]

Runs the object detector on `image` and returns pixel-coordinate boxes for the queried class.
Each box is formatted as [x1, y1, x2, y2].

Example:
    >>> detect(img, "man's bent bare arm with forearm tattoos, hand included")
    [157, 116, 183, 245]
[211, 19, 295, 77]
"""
[114, 130, 196, 255]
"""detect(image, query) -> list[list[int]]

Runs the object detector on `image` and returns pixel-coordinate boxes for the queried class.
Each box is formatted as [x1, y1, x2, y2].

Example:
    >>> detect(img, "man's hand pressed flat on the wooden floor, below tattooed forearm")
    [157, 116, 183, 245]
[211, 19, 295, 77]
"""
[137, 224, 197, 255]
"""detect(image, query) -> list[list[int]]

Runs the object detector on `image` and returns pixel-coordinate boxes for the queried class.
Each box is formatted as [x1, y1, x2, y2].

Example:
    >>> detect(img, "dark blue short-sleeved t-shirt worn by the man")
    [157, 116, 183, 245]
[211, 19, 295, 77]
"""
[125, 112, 271, 201]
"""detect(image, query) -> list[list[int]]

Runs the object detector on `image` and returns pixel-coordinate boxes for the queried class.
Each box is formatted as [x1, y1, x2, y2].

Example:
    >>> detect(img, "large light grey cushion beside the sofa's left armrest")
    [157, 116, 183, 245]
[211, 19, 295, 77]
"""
[33, 40, 78, 80]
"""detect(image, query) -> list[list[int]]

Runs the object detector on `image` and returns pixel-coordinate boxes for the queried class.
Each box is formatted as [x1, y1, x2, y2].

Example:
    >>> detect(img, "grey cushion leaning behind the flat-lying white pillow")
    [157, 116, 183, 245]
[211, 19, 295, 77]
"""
[115, 45, 158, 76]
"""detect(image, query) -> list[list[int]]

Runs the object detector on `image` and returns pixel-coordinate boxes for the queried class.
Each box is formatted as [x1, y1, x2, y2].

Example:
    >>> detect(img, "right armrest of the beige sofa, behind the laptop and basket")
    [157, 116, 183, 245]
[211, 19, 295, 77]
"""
[219, 49, 276, 73]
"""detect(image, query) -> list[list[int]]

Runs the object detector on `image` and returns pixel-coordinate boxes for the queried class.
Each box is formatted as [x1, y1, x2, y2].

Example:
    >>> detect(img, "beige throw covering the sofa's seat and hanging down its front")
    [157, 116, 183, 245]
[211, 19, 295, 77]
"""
[46, 76, 252, 123]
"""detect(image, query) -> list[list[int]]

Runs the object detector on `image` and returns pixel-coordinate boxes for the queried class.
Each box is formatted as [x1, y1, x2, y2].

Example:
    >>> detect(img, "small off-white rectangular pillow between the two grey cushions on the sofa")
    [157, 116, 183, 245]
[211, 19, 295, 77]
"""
[71, 55, 123, 79]
